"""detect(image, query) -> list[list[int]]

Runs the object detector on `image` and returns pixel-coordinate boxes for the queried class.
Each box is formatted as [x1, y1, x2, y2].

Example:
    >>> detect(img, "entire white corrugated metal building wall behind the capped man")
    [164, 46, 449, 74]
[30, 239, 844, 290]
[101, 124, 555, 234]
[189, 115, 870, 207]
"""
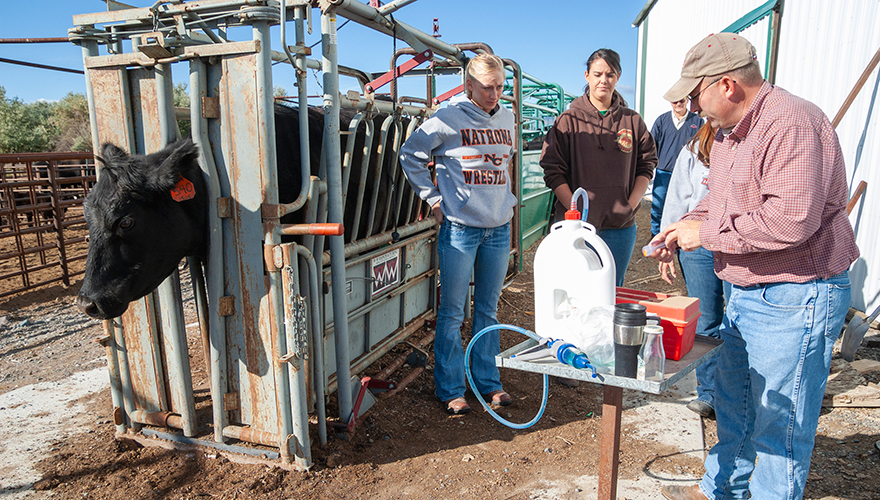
[636, 0, 880, 311]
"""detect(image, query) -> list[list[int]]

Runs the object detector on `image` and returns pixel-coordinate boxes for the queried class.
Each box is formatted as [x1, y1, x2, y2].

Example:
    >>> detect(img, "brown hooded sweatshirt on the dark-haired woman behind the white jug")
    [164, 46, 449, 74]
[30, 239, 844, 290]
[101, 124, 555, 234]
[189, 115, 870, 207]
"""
[541, 93, 657, 229]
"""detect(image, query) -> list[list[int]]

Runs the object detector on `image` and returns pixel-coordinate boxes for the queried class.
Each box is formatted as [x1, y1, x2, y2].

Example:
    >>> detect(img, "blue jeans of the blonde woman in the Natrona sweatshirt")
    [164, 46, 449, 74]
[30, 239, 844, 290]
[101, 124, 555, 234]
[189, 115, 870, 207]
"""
[434, 219, 510, 401]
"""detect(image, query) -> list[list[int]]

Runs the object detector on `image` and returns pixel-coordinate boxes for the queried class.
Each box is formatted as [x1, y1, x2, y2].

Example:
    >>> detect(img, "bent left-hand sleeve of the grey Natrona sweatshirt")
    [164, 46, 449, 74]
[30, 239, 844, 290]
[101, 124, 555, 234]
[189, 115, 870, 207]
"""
[400, 118, 451, 207]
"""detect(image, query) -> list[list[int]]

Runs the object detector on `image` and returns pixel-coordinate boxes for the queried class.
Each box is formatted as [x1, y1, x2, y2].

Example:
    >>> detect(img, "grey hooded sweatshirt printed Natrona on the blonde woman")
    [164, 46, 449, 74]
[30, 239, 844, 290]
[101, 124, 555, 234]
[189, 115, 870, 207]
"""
[400, 95, 516, 228]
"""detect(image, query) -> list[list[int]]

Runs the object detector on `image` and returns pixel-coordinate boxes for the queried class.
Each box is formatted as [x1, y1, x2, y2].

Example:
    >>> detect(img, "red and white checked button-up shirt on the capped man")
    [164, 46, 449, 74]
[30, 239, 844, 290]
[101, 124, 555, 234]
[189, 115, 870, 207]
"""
[683, 82, 859, 286]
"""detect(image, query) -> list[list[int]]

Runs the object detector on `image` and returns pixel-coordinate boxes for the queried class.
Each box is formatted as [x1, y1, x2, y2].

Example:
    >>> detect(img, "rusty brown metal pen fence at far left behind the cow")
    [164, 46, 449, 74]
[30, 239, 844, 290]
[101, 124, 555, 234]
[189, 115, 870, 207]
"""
[0, 152, 95, 297]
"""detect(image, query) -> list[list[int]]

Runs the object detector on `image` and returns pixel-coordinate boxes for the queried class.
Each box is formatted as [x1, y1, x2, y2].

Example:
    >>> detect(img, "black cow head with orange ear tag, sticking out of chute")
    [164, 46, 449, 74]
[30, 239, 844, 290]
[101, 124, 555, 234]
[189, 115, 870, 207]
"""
[77, 139, 207, 319]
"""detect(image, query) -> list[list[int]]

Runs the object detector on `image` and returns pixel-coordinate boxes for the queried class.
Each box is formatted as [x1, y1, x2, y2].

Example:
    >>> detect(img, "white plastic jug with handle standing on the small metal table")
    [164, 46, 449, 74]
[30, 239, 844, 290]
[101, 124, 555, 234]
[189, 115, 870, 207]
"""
[534, 217, 616, 348]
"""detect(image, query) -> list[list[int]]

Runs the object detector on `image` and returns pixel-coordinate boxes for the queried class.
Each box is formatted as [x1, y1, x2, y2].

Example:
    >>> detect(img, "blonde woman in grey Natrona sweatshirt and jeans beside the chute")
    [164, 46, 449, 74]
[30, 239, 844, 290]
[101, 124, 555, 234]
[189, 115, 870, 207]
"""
[400, 54, 516, 414]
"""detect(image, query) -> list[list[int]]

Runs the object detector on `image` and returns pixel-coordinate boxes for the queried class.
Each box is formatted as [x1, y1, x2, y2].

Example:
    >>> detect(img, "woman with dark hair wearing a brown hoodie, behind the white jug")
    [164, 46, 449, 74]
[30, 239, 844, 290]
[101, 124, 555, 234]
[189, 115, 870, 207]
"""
[541, 49, 657, 286]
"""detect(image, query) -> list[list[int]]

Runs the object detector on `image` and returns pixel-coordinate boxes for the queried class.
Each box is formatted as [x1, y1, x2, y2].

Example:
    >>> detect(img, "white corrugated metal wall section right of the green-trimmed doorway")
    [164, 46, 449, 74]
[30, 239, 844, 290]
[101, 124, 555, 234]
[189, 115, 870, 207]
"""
[776, 0, 880, 311]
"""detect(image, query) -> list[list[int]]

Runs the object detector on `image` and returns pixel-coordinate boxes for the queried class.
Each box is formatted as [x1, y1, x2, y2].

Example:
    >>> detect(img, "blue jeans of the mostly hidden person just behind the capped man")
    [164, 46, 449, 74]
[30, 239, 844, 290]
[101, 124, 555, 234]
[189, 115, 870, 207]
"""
[678, 247, 724, 408]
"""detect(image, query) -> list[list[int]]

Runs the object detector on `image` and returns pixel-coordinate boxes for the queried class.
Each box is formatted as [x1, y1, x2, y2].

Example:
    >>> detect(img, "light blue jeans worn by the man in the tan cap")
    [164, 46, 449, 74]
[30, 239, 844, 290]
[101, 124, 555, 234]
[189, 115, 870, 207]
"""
[700, 272, 851, 500]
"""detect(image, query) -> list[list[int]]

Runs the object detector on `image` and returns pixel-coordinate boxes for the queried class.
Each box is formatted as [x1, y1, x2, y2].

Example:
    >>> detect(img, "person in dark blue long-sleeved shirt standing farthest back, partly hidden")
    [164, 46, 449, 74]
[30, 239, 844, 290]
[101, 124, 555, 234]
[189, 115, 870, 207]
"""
[651, 98, 703, 238]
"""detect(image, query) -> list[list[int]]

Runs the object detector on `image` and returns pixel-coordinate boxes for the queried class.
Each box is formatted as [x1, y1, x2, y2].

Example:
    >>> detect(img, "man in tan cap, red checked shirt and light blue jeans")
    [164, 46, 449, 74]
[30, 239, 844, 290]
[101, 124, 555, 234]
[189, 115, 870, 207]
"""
[653, 33, 859, 500]
